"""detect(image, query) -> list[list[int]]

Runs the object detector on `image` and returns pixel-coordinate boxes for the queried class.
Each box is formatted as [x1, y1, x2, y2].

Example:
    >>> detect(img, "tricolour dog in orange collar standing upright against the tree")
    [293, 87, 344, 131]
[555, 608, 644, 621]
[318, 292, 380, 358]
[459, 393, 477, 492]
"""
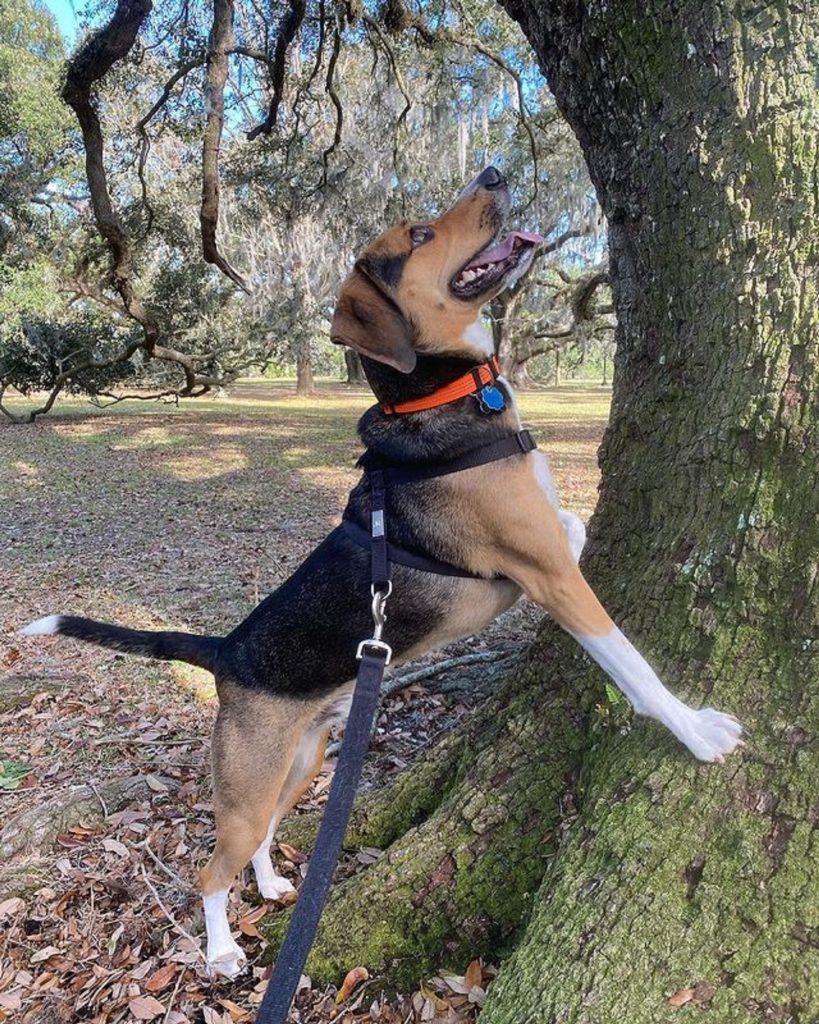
[23, 167, 742, 978]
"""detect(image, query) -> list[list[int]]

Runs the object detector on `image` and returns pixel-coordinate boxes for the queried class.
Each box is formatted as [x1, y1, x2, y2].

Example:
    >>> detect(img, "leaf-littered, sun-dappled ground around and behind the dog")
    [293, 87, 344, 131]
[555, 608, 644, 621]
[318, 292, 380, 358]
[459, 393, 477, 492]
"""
[0, 383, 609, 1024]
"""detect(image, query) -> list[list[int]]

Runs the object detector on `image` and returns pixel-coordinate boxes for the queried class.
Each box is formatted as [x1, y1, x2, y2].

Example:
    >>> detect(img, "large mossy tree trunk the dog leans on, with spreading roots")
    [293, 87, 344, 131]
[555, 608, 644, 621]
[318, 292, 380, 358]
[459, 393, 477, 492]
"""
[272, 0, 819, 1024]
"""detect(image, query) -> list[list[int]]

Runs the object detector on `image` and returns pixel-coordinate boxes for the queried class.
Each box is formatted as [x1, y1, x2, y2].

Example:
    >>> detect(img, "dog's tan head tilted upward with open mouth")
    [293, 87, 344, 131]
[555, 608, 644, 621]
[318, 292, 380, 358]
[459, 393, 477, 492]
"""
[331, 167, 542, 373]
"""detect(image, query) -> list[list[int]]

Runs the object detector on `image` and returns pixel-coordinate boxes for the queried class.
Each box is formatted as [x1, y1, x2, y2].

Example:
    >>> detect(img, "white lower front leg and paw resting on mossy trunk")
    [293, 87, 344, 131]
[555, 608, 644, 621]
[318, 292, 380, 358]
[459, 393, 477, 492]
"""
[572, 628, 742, 761]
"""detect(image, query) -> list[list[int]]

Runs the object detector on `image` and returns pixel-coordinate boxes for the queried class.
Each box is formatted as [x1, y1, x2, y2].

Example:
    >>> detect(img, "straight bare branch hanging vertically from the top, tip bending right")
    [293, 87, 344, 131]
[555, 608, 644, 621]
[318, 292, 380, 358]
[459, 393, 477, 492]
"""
[200, 0, 250, 295]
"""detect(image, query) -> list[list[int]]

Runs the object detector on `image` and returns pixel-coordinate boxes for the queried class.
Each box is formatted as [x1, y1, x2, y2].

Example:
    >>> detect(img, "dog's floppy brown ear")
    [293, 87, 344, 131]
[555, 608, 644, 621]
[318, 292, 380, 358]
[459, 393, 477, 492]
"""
[330, 263, 416, 374]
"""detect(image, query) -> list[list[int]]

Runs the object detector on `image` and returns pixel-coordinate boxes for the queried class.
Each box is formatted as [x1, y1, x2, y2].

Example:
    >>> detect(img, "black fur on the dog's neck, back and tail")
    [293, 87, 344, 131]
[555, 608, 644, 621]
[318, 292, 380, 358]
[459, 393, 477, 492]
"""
[39, 354, 518, 697]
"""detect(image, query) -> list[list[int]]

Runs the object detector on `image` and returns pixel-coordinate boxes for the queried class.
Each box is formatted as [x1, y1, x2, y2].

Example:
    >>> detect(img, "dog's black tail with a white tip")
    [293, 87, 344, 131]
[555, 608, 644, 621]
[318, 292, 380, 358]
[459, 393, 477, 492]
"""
[19, 615, 222, 672]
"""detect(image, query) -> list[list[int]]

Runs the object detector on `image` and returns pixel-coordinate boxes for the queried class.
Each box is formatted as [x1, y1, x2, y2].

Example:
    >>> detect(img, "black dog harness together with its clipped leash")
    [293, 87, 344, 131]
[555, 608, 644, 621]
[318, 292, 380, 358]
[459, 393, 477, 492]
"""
[256, 430, 537, 1024]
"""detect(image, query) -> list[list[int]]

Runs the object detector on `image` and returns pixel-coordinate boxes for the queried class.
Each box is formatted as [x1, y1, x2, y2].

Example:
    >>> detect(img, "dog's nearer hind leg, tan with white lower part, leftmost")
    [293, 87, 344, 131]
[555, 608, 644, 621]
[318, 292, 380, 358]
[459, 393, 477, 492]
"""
[200, 687, 314, 978]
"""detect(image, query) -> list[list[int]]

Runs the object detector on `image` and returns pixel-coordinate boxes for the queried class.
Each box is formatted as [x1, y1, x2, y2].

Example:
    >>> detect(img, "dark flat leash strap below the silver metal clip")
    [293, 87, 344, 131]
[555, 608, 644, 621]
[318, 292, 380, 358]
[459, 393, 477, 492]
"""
[256, 643, 386, 1024]
